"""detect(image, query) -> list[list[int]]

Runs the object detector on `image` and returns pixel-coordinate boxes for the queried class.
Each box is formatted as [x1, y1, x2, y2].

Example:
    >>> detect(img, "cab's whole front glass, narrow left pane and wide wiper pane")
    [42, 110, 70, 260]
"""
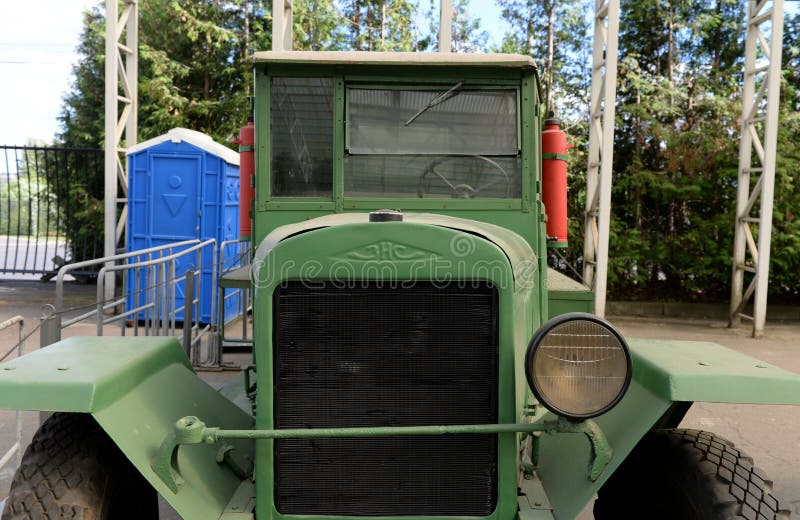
[269, 77, 522, 199]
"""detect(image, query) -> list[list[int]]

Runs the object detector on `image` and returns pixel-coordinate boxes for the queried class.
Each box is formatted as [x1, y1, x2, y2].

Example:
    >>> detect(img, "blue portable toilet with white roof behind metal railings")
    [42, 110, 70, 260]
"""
[126, 128, 240, 323]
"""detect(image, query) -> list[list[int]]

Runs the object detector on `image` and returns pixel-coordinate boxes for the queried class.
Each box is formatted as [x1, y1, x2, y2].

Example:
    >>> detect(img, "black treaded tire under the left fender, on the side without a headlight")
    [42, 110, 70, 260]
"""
[2, 413, 158, 520]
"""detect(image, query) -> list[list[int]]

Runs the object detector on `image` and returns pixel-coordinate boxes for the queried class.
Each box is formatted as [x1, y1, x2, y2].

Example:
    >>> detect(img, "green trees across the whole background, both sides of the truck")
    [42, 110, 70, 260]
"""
[59, 0, 800, 301]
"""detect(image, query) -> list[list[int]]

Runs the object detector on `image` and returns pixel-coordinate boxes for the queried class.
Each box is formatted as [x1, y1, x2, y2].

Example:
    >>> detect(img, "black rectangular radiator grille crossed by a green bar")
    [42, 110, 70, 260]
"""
[274, 282, 498, 516]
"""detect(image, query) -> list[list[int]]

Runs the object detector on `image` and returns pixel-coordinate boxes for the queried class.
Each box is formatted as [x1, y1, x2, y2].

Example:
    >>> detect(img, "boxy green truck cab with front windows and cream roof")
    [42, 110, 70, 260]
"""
[254, 52, 542, 246]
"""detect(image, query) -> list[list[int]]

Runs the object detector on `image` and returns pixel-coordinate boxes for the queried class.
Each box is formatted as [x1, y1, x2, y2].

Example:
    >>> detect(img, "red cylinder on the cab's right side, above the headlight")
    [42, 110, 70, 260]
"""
[542, 117, 572, 248]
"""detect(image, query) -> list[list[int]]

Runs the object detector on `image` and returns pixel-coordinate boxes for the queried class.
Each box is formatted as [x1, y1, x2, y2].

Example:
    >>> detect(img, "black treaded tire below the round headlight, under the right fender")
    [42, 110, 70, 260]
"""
[594, 430, 791, 520]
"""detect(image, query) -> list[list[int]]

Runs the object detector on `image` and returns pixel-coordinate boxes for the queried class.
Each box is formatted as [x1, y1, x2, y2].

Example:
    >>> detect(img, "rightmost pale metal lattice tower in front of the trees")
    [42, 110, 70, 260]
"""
[730, 0, 783, 337]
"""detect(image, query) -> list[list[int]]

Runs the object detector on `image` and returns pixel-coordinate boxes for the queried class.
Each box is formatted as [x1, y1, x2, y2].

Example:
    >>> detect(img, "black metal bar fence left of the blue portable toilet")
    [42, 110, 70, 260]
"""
[0, 146, 104, 274]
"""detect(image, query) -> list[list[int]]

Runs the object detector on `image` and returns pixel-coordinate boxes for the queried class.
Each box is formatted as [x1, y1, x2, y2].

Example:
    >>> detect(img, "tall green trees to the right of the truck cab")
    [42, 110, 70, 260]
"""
[528, 0, 800, 302]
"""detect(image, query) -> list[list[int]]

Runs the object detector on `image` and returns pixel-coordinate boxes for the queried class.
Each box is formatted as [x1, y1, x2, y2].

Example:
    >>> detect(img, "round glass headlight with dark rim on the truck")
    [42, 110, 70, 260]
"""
[525, 312, 631, 419]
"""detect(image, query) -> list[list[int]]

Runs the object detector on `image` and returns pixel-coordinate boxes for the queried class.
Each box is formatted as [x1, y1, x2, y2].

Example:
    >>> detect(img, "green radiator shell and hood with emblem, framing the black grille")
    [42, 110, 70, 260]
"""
[250, 220, 542, 520]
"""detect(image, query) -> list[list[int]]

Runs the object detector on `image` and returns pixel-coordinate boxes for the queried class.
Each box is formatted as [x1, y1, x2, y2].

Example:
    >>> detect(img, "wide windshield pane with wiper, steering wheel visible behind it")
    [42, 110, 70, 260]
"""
[345, 86, 521, 198]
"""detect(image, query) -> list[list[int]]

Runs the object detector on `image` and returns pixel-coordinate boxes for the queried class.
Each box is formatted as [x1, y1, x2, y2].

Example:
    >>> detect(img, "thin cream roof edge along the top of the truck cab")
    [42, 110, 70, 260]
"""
[253, 51, 536, 69]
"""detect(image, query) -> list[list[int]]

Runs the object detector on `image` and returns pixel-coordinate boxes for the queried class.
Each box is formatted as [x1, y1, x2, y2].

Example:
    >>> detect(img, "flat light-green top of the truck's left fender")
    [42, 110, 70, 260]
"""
[0, 337, 190, 415]
